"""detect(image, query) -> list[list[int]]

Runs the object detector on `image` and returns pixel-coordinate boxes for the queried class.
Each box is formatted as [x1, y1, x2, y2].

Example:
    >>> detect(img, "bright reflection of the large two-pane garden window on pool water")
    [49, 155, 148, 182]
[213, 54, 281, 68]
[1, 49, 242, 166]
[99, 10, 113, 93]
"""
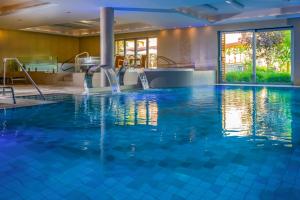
[222, 88, 292, 147]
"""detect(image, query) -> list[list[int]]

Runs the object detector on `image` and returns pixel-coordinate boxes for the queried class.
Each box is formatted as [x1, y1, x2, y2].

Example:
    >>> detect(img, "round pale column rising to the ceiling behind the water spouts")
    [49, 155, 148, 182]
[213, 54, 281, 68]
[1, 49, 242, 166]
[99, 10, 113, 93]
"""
[100, 7, 114, 87]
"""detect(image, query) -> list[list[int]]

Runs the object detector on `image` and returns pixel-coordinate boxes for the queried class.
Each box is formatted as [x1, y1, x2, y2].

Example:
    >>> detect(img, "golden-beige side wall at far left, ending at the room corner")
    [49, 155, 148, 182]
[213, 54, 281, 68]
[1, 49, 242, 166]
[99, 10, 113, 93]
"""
[0, 29, 79, 63]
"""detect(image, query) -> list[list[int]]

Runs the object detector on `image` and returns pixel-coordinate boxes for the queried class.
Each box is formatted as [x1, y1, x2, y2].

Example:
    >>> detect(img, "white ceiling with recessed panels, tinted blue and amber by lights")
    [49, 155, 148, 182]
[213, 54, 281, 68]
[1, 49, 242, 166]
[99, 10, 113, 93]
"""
[0, 0, 300, 36]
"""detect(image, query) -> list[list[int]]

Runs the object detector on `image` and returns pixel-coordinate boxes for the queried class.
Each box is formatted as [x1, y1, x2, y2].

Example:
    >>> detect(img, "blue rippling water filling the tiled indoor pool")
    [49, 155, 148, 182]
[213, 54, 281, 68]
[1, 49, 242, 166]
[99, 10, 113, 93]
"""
[0, 86, 300, 200]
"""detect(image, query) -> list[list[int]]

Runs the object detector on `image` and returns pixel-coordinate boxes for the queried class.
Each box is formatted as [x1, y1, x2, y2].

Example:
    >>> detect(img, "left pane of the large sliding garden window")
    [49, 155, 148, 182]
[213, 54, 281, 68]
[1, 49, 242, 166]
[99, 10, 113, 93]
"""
[221, 32, 253, 83]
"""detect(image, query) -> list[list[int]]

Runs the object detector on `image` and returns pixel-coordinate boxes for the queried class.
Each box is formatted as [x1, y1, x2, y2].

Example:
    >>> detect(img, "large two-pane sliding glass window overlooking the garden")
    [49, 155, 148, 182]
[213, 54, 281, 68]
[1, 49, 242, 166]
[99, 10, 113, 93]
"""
[220, 29, 291, 83]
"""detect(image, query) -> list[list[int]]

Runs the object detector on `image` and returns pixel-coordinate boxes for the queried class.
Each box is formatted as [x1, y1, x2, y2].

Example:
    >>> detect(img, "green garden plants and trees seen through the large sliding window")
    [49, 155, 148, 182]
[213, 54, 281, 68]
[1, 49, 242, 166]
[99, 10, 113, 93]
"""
[225, 30, 291, 83]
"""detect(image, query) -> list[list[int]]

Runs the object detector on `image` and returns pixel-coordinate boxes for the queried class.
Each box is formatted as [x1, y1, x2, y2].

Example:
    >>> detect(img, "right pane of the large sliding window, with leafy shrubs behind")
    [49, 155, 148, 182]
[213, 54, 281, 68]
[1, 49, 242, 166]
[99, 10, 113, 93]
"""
[255, 29, 292, 84]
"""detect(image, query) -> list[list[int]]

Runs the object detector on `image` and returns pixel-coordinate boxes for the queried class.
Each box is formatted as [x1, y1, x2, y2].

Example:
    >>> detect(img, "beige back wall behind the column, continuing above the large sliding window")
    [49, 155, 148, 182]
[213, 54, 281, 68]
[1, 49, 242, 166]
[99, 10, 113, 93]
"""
[79, 20, 296, 69]
